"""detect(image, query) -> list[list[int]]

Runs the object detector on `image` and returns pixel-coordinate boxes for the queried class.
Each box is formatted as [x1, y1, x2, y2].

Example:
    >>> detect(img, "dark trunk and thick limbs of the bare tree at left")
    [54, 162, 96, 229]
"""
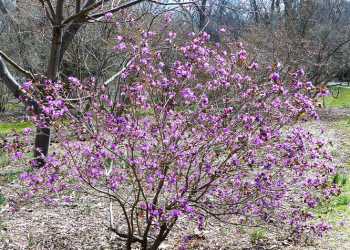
[0, 0, 144, 167]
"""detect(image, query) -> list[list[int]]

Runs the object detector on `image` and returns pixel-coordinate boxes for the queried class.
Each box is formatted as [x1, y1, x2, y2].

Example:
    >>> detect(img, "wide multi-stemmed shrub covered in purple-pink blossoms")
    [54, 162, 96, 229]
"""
[4, 28, 339, 249]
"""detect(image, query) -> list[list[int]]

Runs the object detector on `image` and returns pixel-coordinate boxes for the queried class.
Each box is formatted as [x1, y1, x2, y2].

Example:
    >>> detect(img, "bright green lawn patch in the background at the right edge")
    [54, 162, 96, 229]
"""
[324, 87, 350, 108]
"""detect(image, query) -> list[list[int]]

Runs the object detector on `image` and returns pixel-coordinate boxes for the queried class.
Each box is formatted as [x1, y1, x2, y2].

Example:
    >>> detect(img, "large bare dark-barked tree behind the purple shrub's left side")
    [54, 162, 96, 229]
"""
[0, 0, 153, 166]
